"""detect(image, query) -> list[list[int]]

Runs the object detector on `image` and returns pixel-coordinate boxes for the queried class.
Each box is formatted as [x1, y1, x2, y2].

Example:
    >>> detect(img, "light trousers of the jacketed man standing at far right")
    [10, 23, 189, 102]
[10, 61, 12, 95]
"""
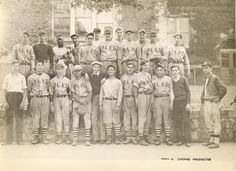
[204, 101, 221, 144]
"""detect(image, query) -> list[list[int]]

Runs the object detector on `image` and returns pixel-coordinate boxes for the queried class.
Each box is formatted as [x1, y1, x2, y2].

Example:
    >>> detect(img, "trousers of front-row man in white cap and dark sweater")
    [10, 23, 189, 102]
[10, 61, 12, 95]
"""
[91, 95, 105, 141]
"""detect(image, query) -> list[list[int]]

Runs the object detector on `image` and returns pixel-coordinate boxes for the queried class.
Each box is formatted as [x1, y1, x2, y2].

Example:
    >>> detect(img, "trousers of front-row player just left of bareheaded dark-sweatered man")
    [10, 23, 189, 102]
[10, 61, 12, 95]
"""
[153, 96, 171, 138]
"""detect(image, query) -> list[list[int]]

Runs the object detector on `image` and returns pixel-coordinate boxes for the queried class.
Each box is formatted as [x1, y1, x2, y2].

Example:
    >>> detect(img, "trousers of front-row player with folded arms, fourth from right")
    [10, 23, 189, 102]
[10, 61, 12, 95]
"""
[138, 94, 152, 136]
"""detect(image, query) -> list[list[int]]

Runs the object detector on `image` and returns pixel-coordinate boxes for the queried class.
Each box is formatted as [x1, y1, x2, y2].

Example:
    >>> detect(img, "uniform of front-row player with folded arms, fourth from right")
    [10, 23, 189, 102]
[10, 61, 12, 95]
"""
[133, 71, 152, 137]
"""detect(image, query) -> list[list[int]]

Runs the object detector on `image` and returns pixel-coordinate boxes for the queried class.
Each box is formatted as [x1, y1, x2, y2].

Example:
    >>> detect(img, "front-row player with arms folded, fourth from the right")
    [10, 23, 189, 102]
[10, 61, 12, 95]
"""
[133, 61, 152, 146]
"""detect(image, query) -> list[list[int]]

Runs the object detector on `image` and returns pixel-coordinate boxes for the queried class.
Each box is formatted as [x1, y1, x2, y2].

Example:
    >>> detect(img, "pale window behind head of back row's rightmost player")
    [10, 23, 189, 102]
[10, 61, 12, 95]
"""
[167, 18, 190, 48]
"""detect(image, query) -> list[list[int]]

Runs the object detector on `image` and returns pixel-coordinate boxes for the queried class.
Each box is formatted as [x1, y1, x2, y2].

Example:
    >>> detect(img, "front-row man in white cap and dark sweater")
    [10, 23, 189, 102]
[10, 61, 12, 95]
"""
[89, 61, 105, 144]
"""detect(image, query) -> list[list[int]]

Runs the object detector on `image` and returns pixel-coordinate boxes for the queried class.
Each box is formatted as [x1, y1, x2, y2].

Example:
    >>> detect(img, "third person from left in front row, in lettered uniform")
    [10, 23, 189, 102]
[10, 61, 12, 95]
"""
[49, 63, 71, 144]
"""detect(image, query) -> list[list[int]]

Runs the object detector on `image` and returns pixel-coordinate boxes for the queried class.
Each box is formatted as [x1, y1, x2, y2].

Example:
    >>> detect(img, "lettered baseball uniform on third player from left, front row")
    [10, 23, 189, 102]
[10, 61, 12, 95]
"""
[49, 76, 71, 136]
